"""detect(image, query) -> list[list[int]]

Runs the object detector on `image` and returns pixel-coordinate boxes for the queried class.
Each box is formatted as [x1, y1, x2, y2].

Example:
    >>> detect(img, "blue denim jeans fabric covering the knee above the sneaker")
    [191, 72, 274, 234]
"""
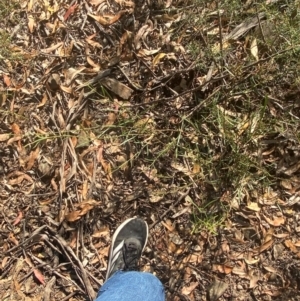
[95, 271, 165, 301]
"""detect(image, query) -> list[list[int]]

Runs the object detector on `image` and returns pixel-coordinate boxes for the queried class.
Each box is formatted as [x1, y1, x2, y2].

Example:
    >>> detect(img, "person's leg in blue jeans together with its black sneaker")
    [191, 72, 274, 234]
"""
[96, 218, 165, 301]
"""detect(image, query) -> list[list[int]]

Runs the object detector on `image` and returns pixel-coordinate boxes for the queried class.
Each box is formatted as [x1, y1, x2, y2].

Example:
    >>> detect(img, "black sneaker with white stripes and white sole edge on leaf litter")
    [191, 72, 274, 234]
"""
[106, 217, 148, 280]
